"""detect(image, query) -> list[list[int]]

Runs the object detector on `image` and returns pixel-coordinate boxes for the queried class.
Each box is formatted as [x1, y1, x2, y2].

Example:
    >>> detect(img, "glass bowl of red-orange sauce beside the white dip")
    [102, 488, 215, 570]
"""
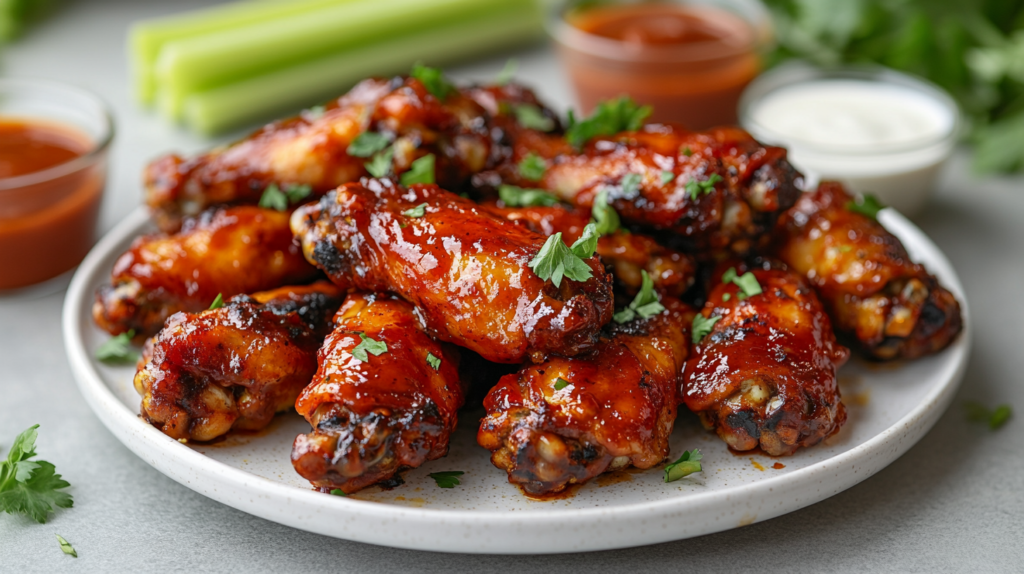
[547, 0, 772, 130]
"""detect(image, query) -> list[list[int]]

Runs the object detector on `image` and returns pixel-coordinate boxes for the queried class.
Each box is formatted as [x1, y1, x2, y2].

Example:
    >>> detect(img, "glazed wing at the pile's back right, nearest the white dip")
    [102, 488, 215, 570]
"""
[474, 124, 802, 259]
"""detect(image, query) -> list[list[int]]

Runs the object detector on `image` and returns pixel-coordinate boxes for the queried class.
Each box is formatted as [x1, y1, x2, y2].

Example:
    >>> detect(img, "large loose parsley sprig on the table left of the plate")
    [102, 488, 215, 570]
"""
[0, 425, 73, 524]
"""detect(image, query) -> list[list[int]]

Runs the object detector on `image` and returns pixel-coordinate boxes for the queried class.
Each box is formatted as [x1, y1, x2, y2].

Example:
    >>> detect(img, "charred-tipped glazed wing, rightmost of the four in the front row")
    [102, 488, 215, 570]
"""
[681, 261, 849, 456]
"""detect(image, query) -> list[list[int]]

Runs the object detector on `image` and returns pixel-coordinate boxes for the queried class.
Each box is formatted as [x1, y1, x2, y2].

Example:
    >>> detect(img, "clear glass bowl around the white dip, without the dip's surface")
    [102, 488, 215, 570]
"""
[739, 61, 963, 216]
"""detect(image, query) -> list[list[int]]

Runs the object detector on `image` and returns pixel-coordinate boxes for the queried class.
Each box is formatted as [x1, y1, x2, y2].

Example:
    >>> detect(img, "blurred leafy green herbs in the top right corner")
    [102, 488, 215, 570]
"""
[763, 0, 1024, 172]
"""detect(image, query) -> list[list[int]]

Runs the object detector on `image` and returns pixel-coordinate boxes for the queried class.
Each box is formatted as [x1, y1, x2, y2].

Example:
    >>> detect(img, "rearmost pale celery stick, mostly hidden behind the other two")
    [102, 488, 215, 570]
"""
[128, 0, 355, 103]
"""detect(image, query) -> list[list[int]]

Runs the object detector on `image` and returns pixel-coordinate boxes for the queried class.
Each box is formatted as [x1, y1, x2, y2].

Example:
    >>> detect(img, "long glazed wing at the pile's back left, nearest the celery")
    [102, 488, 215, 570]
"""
[144, 78, 505, 230]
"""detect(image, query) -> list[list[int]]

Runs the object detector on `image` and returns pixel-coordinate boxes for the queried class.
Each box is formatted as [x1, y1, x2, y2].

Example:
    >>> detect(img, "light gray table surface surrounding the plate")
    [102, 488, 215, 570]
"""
[0, 0, 1024, 573]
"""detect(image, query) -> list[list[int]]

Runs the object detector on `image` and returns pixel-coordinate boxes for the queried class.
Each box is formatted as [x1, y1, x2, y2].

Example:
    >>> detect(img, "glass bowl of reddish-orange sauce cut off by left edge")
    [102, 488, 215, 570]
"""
[0, 79, 114, 296]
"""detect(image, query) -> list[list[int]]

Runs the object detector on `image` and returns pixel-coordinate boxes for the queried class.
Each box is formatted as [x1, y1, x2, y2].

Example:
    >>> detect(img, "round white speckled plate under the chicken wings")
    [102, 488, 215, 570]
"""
[63, 204, 971, 554]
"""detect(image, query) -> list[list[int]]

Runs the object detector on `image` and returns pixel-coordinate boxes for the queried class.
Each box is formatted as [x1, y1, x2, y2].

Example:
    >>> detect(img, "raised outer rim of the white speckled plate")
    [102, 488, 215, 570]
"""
[61, 207, 973, 554]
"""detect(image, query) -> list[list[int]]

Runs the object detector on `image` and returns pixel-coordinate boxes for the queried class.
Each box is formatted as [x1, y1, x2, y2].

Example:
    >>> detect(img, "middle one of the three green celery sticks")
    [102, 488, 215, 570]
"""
[156, 0, 534, 117]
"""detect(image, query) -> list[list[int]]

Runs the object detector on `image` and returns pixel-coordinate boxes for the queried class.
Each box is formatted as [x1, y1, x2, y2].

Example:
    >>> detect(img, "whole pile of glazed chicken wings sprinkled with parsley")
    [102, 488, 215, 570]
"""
[93, 70, 962, 495]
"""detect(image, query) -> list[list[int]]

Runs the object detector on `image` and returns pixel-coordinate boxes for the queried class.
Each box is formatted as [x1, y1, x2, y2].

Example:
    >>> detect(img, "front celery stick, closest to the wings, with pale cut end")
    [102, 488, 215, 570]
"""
[184, 9, 541, 135]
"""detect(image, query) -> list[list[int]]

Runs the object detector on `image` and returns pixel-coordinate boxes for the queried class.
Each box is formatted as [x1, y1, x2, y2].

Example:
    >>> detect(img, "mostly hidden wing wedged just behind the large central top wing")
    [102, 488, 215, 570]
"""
[482, 202, 696, 297]
